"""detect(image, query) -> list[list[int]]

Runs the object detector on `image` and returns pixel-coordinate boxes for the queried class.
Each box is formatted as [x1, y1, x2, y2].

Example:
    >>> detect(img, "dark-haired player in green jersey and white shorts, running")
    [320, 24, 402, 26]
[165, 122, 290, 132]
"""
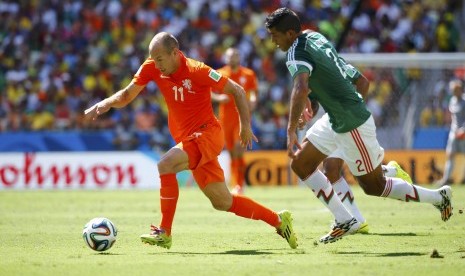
[265, 8, 452, 243]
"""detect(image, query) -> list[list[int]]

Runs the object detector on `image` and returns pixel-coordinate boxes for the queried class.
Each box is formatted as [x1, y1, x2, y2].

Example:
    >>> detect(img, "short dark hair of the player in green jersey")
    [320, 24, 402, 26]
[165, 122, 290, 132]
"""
[265, 8, 301, 33]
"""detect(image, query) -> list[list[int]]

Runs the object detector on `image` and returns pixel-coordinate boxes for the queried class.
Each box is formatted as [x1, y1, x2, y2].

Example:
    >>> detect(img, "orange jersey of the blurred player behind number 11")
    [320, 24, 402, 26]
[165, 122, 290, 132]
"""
[218, 65, 258, 125]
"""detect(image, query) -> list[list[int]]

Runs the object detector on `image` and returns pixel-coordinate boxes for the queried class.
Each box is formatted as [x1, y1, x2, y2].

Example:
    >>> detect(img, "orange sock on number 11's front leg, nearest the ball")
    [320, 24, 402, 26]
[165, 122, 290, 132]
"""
[160, 173, 179, 235]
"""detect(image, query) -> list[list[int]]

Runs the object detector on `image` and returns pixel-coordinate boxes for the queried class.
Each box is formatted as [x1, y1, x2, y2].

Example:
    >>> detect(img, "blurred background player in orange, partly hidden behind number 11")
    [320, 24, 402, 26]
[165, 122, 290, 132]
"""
[212, 48, 258, 194]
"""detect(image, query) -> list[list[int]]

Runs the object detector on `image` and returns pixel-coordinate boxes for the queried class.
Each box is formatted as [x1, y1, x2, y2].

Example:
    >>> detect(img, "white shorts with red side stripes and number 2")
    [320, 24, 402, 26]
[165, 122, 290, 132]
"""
[305, 114, 384, 176]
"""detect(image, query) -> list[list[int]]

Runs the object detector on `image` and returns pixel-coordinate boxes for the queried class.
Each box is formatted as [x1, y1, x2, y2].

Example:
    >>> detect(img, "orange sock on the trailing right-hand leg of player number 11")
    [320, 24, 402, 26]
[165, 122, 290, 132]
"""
[228, 195, 280, 227]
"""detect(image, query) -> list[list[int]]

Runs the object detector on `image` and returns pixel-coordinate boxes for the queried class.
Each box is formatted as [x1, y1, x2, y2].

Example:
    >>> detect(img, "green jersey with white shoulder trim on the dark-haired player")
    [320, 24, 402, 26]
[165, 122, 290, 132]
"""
[286, 32, 371, 133]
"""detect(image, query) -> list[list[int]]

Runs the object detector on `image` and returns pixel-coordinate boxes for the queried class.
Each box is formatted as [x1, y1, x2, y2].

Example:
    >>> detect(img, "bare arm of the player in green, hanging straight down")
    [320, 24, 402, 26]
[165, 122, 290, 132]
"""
[287, 73, 310, 159]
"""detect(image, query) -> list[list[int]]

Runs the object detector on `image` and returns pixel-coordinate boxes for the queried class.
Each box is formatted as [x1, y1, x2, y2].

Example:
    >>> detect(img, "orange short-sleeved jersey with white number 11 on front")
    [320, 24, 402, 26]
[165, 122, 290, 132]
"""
[133, 54, 228, 143]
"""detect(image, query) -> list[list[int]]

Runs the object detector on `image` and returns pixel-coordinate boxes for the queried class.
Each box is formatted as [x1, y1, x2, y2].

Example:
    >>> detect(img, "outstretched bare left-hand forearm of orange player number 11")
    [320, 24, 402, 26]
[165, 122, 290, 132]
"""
[84, 82, 144, 120]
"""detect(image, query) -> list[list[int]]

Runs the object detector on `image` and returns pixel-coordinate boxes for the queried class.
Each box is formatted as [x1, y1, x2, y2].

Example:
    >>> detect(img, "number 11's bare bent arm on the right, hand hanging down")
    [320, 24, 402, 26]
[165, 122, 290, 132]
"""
[223, 80, 258, 148]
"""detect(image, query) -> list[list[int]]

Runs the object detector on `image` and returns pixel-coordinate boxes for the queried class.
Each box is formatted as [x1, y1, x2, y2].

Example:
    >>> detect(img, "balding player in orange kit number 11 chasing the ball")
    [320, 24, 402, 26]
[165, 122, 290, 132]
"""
[84, 32, 297, 249]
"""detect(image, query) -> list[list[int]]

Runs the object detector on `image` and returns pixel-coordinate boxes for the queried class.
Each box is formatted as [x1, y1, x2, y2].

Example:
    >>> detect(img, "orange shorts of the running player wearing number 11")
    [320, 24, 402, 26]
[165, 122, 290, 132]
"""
[182, 121, 224, 189]
